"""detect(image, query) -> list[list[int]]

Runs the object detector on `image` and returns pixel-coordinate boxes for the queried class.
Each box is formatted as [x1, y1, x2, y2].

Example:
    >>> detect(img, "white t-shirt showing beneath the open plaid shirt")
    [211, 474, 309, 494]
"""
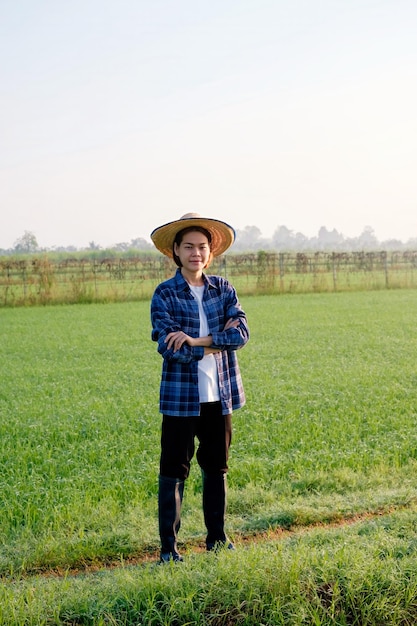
[190, 285, 220, 402]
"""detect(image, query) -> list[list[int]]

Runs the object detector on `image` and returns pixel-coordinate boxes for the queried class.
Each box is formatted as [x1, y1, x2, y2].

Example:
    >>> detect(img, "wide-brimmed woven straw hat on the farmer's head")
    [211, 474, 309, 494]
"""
[151, 213, 235, 258]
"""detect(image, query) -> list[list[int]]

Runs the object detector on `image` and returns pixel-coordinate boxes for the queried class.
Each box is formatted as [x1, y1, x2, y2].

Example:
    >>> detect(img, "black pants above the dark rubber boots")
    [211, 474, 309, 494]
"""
[160, 402, 232, 480]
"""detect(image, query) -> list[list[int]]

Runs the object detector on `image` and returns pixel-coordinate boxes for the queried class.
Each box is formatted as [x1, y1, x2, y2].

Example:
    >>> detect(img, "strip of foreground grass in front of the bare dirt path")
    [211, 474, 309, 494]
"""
[0, 508, 417, 626]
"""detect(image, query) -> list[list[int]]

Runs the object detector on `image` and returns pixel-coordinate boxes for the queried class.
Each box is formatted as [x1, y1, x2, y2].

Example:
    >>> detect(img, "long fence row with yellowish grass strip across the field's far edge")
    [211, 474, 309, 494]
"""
[0, 251, 417, 306]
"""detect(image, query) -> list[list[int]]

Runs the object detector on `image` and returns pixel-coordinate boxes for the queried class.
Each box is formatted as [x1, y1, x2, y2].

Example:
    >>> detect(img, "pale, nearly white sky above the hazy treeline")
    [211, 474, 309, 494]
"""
[0, 0, 417, 248]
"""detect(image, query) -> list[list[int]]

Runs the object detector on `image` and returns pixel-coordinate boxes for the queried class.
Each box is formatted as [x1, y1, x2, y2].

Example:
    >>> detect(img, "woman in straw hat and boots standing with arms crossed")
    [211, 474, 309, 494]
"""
[151, 213, 249, 562]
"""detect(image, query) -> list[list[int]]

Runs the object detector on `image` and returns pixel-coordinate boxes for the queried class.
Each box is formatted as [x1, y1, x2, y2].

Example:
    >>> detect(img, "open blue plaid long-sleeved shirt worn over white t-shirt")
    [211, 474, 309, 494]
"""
[151, 269, 249, 417]
